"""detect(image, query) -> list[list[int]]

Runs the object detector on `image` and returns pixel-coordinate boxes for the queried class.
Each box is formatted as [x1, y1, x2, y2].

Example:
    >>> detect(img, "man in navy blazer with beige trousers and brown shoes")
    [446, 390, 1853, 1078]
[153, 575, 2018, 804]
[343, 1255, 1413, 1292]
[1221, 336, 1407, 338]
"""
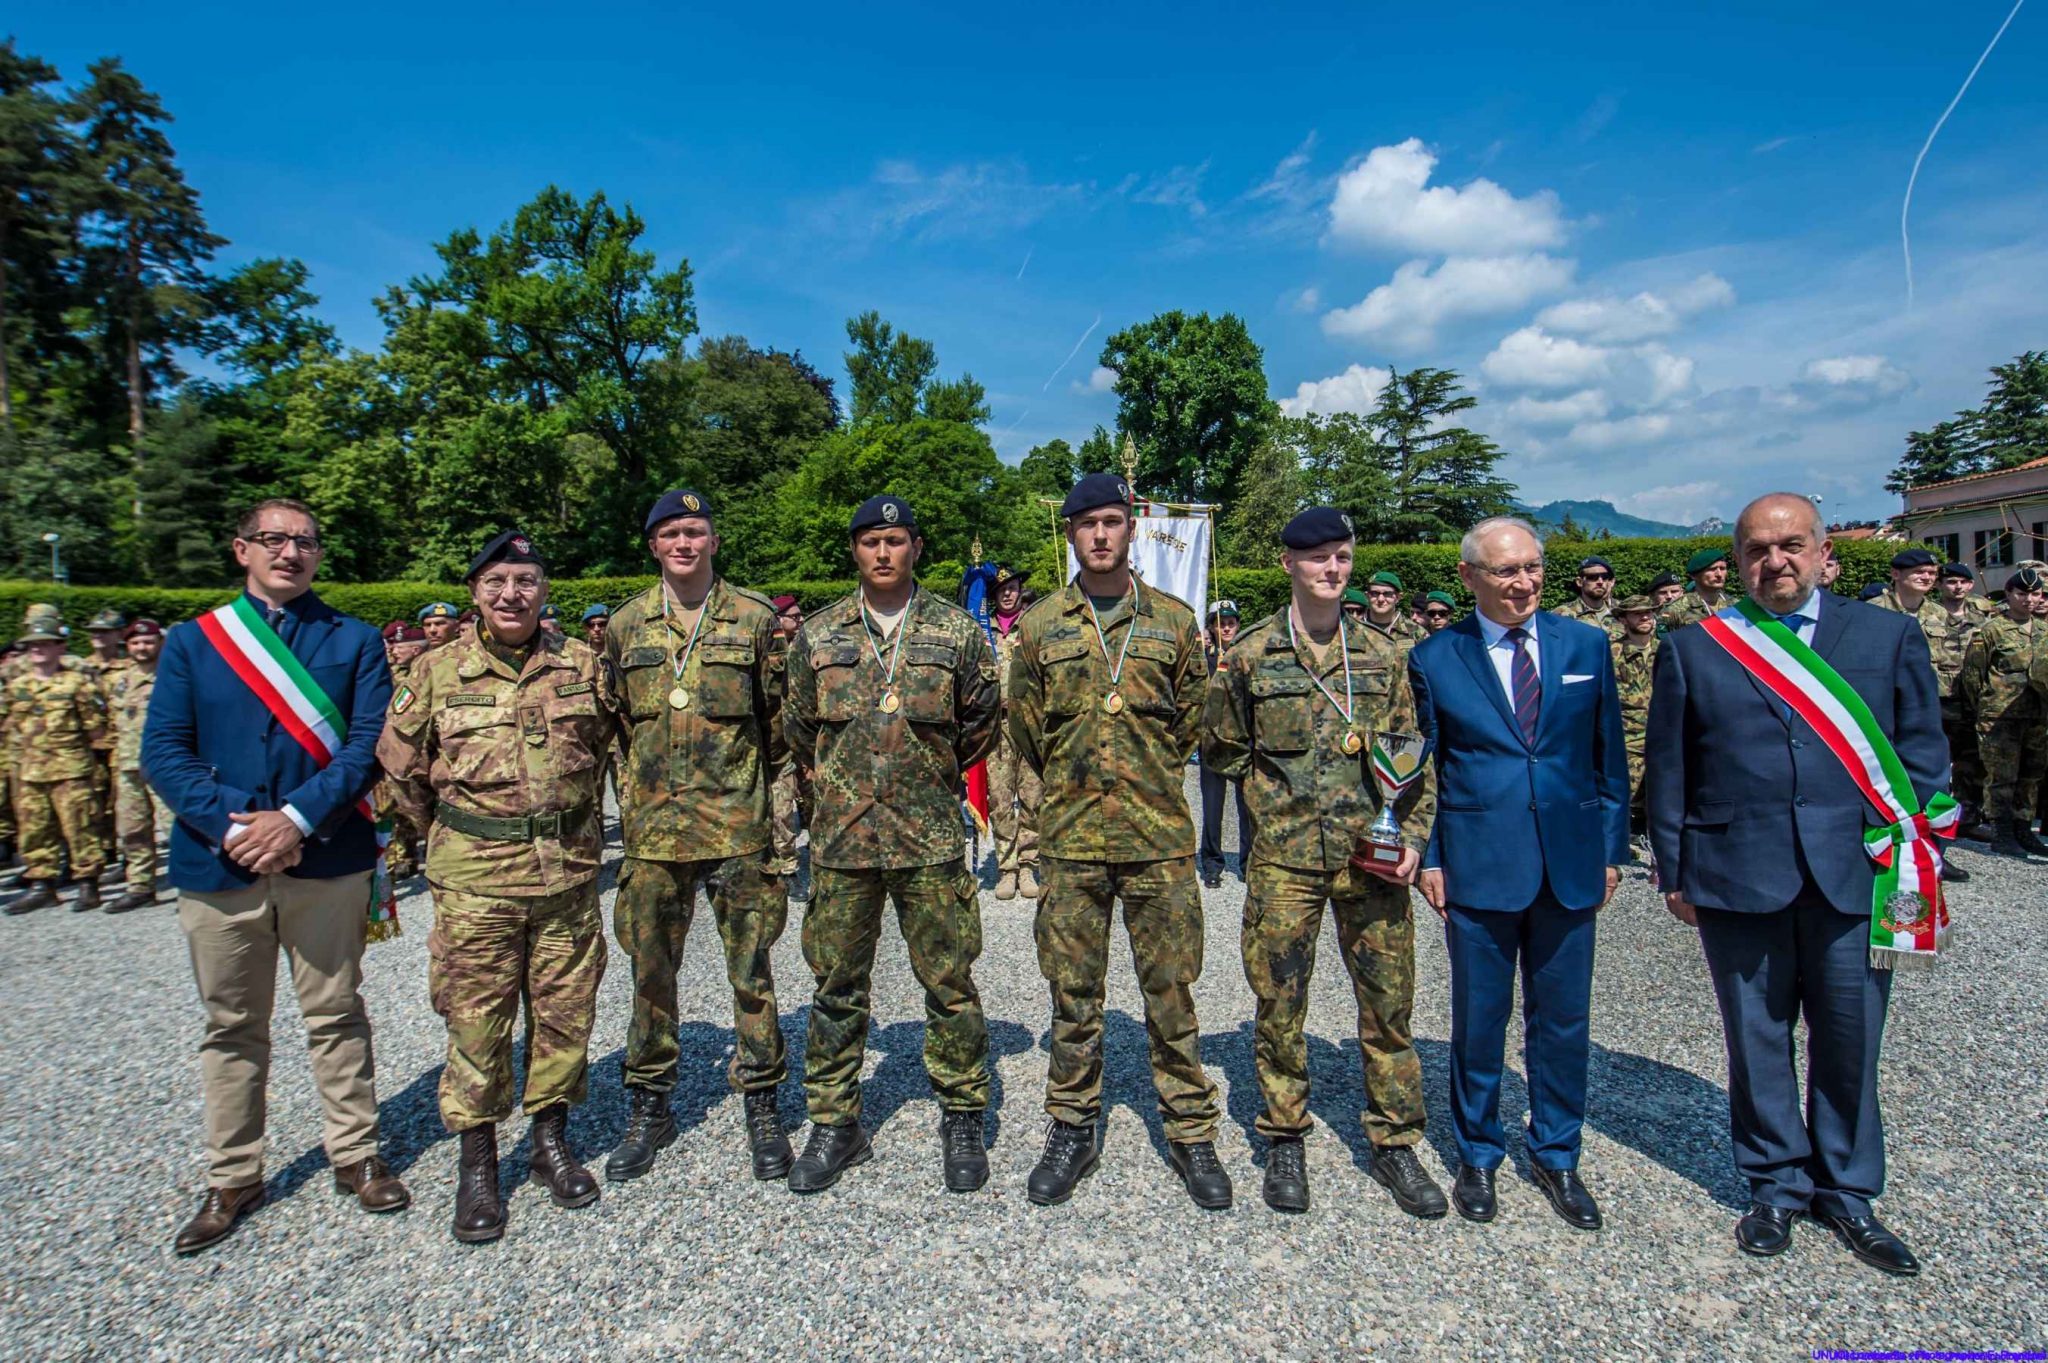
[141, 497, 410, 1255]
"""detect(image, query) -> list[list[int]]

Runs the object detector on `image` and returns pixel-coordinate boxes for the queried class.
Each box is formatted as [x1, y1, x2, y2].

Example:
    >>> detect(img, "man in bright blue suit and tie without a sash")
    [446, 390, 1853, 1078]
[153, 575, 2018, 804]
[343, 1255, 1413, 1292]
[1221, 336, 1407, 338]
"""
[1409, 516, 1628, 1230]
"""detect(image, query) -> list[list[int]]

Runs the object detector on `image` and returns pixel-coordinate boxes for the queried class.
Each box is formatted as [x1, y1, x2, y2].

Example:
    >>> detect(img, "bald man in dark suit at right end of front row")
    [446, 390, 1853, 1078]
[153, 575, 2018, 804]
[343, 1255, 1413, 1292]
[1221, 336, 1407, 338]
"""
[1647, 493, 1948, 1275]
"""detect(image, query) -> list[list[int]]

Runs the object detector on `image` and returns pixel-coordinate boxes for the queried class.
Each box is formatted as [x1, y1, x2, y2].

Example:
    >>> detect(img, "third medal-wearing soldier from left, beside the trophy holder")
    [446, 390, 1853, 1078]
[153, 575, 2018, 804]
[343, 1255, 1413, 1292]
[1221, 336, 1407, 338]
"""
[1008, 473, 1228, 1210]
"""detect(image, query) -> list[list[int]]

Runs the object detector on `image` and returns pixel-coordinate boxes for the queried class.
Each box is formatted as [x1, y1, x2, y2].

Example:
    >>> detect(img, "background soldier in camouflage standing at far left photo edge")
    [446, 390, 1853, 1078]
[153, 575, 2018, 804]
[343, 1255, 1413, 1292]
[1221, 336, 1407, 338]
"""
[0, 616, 113, 913]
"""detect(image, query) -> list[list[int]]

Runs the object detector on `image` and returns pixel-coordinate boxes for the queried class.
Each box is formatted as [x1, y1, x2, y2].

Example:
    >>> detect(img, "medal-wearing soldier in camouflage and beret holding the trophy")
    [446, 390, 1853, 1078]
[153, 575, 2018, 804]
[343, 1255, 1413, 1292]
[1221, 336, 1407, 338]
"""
[1202, 508, 1450, 1218]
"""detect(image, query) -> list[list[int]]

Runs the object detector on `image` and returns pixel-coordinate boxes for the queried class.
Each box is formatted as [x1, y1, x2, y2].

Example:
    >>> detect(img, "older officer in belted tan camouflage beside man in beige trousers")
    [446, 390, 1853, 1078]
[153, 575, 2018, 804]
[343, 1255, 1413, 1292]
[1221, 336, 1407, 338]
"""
[377, 530, 618, 1242]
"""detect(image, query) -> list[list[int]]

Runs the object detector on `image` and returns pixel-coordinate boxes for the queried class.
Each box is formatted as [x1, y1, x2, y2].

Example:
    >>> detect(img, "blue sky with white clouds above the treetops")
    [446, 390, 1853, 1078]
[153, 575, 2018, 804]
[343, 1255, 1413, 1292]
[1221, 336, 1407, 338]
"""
[28, 0, 2048, 520]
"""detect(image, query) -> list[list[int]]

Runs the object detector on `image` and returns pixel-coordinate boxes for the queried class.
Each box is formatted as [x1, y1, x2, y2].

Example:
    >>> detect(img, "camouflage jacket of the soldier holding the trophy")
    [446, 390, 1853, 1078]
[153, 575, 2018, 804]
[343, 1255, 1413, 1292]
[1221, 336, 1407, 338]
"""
[1202, 612, 1436, 872]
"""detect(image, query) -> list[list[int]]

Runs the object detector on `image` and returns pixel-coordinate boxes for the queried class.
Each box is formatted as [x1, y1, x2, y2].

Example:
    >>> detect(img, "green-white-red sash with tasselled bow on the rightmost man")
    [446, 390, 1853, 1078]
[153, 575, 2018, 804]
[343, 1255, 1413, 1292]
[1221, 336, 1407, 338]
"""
[1700, 600, 1962, 970]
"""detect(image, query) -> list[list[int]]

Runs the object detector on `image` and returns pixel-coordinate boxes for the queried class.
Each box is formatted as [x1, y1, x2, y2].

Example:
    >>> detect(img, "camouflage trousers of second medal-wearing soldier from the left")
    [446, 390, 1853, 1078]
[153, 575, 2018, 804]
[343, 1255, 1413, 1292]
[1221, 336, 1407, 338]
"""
[803, 858, 989, 1126]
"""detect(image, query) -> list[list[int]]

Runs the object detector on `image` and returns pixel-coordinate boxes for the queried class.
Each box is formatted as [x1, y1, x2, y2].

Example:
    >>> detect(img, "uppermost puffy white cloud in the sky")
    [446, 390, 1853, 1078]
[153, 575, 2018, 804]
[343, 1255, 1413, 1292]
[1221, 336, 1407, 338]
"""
[1329, 137, 1565, 256]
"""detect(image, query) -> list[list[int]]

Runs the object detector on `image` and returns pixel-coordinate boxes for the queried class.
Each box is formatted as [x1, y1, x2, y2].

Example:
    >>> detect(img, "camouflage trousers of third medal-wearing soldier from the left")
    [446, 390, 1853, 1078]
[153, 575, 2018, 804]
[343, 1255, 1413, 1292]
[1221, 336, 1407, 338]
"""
[1036, 858, 1221, 1140]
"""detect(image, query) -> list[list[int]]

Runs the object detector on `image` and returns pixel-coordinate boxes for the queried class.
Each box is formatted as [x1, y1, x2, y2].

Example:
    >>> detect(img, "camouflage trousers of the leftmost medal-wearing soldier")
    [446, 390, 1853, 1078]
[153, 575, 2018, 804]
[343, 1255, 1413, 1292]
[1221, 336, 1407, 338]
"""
[612, 851, 788, 1093]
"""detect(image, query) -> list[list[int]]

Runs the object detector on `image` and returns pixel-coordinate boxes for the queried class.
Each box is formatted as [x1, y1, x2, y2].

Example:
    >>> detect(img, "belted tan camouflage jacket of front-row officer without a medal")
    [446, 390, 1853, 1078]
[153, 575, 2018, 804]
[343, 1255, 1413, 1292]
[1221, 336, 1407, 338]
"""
[377, 624, 618, 894]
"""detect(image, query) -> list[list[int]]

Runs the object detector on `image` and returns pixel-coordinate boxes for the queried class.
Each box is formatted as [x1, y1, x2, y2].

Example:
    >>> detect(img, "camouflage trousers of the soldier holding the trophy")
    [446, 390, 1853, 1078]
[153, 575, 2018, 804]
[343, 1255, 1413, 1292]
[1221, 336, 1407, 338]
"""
[1243, 862, 1423, 1146]
